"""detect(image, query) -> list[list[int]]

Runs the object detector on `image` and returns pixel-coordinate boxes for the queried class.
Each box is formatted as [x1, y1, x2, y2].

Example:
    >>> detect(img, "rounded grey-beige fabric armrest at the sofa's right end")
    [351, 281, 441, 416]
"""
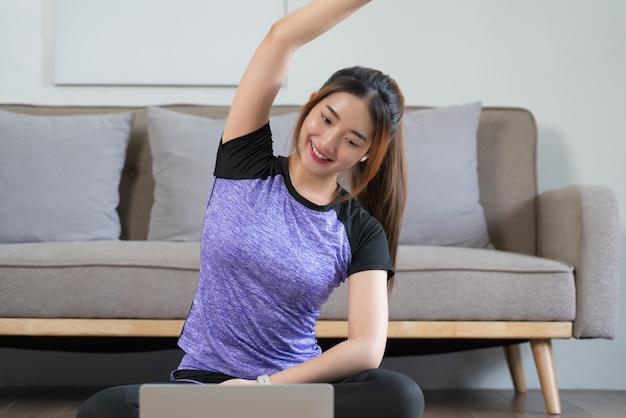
[539, 185, 620, 338]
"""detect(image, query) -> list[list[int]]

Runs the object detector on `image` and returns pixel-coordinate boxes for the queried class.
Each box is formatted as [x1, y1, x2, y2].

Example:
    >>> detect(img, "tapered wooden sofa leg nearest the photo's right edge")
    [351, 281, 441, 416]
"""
[530, 339, 561, 415]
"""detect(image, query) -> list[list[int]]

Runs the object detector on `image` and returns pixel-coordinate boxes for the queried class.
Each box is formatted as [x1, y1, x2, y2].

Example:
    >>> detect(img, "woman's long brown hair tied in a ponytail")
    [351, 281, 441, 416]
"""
[292, 66, 407, 292]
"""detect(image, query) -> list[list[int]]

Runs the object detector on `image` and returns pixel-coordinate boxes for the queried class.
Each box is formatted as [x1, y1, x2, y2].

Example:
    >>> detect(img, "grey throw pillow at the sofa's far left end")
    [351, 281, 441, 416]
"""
[0, 110, 134, 243]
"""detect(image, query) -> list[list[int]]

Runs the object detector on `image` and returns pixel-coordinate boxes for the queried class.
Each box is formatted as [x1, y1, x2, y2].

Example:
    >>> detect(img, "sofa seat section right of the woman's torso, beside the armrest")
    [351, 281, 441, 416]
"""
[321, 246, 576, 321]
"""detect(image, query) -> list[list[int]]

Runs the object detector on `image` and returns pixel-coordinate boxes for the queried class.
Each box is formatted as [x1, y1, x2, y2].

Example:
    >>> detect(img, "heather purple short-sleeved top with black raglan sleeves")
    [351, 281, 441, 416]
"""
[178, 124, 393, 379]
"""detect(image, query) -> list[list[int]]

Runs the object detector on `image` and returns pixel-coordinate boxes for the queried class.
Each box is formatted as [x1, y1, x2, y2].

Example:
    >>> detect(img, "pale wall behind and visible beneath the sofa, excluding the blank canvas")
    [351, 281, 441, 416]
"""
[0, 0, 626, 389]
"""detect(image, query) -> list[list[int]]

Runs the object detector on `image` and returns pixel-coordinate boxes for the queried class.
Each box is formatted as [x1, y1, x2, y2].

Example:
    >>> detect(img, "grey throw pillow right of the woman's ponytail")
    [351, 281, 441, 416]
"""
[400, 103, 490, 248]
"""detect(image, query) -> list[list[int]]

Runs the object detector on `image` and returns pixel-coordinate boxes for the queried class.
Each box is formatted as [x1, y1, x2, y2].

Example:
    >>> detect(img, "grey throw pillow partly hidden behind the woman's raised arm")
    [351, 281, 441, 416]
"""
[148, 107, 298, 241]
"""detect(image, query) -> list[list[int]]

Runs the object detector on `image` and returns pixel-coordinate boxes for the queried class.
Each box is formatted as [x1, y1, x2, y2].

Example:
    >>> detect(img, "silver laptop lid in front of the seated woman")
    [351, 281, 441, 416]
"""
[139, 383, 334, 418]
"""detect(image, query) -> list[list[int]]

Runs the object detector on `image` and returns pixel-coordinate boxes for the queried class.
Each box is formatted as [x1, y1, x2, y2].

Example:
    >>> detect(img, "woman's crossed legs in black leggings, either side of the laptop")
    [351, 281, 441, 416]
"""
[76, 369, 424, 418]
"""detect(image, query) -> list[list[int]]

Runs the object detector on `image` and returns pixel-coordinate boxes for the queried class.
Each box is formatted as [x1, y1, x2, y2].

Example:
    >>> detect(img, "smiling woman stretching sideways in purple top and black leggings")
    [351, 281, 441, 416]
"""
[78, 0, 424, 418]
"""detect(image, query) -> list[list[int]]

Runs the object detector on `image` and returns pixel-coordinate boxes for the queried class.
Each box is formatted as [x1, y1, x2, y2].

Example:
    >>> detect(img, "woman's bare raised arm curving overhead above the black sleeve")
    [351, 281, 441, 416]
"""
[222, 0, 370, 142]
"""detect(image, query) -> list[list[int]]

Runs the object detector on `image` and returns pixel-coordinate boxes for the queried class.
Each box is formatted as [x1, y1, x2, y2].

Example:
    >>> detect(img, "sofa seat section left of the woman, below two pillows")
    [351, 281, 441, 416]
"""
[0, 241, 200, 319]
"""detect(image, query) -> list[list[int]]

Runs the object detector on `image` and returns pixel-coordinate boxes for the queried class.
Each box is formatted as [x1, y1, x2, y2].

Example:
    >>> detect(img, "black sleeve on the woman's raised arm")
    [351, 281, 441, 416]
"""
[214, 123, 276, 180]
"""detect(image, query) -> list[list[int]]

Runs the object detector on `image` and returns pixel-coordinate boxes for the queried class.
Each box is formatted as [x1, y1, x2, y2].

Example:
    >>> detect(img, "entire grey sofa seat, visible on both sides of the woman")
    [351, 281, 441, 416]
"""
[0, 241, 576, 321]
